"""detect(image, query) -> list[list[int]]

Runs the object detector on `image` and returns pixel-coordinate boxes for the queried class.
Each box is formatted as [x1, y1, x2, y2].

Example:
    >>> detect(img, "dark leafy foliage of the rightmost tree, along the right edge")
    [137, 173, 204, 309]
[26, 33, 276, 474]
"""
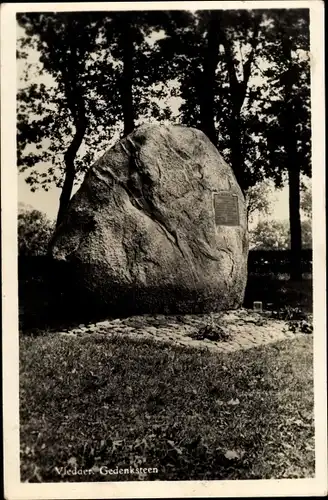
[259, 9, 311, 185]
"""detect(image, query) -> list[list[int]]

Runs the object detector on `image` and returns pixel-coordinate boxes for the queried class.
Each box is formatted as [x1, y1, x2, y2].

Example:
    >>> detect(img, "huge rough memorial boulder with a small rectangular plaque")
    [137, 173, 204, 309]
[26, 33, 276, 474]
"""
[51, 124, 248, 314]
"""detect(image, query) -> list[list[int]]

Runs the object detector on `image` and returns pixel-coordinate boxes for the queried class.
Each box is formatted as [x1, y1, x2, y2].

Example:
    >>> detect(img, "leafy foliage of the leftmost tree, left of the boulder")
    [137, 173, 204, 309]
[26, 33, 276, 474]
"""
[17, 13, 101, 189]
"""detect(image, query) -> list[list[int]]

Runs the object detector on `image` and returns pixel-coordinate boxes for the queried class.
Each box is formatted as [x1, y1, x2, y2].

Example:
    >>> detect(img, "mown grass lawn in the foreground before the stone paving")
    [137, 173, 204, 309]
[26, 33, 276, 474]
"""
[20, 334, 314, 482]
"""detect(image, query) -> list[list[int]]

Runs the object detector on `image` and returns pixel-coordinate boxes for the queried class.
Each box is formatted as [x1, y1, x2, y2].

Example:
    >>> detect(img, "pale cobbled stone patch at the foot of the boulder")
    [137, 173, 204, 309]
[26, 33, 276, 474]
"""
[58, 309, 304, 352]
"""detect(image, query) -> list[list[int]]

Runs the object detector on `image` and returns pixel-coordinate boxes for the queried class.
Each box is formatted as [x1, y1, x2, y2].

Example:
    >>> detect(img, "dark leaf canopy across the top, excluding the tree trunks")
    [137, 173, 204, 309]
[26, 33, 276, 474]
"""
[18, 9, 310, 186]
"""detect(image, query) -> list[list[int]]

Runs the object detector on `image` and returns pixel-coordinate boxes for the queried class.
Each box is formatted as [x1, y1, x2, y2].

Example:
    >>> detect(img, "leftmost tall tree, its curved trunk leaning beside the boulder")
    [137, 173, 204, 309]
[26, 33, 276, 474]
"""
[18, 13, 104, 225]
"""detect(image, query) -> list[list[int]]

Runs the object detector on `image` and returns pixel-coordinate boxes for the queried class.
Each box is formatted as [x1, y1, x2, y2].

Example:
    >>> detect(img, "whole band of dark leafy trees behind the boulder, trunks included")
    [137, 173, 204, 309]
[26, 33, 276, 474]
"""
[17, 9, 311, 254]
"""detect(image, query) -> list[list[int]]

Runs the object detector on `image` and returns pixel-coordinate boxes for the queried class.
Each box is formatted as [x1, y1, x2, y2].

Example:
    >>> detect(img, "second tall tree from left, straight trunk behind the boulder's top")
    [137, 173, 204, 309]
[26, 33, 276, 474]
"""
[98, 11, 173, 135]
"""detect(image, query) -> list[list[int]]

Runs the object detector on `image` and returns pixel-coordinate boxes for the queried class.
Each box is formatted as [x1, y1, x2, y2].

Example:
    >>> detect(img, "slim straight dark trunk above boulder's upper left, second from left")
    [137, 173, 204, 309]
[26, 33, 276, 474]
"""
[121, 23, 135, 135]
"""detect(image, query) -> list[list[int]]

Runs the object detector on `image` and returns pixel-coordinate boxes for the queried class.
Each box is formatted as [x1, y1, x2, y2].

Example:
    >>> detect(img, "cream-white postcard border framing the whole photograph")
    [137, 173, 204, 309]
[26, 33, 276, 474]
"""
[1, 0, 327, 500]
